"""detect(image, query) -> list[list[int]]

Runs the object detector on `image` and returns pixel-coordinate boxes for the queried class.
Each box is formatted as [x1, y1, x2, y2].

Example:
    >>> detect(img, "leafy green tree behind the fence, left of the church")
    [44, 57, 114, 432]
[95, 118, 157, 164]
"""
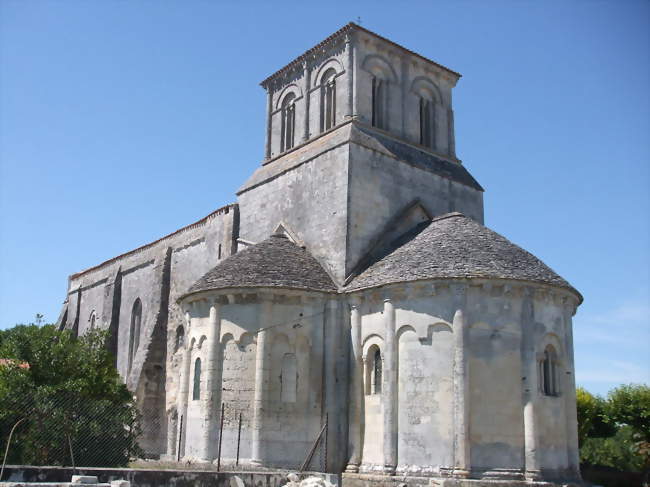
[0, 325, 141, 467]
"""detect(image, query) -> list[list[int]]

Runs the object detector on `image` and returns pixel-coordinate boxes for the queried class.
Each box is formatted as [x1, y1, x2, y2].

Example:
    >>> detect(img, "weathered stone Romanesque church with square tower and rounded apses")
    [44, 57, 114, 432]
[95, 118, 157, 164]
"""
[59, 23, 582, 485]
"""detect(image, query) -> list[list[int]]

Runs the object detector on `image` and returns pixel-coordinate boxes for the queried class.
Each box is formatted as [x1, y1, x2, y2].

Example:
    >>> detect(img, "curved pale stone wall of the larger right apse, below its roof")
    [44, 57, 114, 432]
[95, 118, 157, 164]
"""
[351, 279, 577, 480]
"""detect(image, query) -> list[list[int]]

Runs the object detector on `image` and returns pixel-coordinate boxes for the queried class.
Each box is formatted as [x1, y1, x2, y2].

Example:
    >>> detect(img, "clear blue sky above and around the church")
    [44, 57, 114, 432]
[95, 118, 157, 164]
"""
[0, 0, 650, 393]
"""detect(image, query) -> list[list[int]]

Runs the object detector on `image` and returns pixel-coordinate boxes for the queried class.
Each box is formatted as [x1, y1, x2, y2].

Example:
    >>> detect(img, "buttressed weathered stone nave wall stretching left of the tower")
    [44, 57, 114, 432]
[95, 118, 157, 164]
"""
[59, 205, 238, 456]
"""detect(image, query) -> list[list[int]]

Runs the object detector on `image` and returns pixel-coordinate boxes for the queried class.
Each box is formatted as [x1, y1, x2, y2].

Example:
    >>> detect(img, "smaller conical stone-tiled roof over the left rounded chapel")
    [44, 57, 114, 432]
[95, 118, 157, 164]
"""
[186, 235, 336, 294]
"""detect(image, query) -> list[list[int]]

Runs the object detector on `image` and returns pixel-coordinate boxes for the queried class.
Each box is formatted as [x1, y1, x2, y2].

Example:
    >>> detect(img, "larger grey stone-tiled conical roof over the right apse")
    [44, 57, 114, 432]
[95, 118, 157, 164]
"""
[346, 213, 580, 296]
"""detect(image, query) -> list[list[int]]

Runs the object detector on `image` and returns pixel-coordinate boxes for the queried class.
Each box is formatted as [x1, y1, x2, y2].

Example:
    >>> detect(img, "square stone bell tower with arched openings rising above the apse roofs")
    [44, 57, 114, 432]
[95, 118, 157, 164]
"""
[237, 23, 483, 285]
